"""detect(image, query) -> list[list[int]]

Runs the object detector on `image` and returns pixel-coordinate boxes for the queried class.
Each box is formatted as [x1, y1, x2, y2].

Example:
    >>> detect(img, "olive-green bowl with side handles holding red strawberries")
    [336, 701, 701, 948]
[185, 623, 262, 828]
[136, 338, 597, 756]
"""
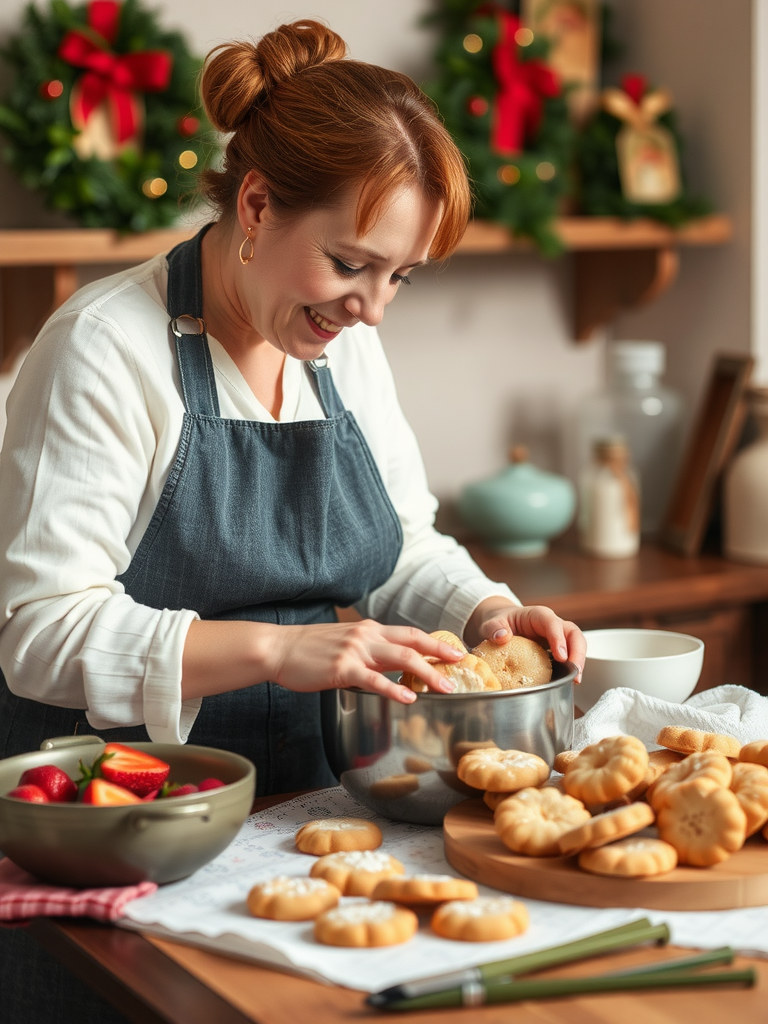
[0, 736, 256, 886]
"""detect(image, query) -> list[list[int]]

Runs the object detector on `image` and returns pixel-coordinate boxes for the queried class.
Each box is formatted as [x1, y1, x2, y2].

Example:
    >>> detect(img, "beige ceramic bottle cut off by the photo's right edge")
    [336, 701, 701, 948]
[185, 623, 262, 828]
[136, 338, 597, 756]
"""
[723, 388, 768, 564]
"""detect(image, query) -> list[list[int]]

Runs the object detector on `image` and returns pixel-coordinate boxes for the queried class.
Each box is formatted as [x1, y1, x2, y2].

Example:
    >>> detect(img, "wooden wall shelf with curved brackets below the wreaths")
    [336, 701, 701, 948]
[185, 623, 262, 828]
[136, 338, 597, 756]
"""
[0, 215, 732, 366]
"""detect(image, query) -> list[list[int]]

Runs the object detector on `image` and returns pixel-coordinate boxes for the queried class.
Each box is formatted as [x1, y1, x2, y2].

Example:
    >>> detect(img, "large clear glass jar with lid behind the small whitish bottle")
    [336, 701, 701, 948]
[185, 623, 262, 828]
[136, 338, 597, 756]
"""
[577, 341, 683, 536]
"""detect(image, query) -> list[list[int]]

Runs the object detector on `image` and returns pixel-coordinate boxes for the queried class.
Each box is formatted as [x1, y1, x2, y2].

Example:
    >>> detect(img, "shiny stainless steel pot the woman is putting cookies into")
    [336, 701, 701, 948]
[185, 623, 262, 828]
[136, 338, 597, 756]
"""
[322, 662, 578, 825]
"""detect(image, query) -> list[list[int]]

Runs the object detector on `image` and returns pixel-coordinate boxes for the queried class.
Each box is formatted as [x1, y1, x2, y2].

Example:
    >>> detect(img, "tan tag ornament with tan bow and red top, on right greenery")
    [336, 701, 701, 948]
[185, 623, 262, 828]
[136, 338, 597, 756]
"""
[601, 75, 681, 205]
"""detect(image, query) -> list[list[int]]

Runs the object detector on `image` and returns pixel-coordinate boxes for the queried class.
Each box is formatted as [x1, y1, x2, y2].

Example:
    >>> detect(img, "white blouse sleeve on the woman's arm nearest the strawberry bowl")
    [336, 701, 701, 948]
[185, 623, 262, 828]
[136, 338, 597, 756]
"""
[0, 288, 200, 742]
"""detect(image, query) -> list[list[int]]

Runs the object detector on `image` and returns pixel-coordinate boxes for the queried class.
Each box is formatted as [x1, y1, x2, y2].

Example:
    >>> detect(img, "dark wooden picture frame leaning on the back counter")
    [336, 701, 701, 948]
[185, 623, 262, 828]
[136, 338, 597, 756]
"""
[659, 353, 755, 557]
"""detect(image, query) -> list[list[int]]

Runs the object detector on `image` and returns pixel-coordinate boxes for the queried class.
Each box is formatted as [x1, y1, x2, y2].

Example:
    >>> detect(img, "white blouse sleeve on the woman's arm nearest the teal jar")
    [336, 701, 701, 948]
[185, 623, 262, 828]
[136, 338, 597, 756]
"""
[333, 329, 520, 636]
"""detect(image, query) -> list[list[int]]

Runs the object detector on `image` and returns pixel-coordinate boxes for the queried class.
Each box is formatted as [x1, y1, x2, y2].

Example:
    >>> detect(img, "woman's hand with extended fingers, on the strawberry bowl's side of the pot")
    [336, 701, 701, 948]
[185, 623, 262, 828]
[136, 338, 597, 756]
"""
[269, 620, 463, 703]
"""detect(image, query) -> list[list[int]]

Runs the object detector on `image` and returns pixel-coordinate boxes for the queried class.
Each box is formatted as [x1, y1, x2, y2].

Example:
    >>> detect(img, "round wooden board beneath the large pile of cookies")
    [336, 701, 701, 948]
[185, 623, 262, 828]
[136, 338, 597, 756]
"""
[443, 800, 768, 910]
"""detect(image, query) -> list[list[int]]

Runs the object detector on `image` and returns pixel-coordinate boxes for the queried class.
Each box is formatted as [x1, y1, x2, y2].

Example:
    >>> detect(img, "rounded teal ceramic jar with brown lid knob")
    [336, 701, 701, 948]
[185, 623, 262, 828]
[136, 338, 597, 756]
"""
[457, 445, 575, 557]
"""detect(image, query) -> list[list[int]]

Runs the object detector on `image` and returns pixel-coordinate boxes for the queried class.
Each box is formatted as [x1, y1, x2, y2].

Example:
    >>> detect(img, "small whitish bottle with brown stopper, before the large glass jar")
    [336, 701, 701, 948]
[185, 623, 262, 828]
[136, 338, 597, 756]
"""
[579, 436, 640, 558]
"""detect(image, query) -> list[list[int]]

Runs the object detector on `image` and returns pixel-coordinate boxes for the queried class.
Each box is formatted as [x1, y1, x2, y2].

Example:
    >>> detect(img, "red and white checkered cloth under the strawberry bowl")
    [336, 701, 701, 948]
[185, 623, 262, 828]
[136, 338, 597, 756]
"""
[0, 857, 158, 921]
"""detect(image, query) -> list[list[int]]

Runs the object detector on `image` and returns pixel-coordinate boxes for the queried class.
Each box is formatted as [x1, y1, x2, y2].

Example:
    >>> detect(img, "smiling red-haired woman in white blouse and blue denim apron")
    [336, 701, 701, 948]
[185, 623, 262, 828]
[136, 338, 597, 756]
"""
[0, 22, 585, 1020]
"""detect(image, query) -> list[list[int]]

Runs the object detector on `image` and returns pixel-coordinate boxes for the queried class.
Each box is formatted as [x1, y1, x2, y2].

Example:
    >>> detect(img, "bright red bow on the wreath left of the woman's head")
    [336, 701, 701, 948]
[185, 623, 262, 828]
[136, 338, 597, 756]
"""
[58, 0, 173, 142]
